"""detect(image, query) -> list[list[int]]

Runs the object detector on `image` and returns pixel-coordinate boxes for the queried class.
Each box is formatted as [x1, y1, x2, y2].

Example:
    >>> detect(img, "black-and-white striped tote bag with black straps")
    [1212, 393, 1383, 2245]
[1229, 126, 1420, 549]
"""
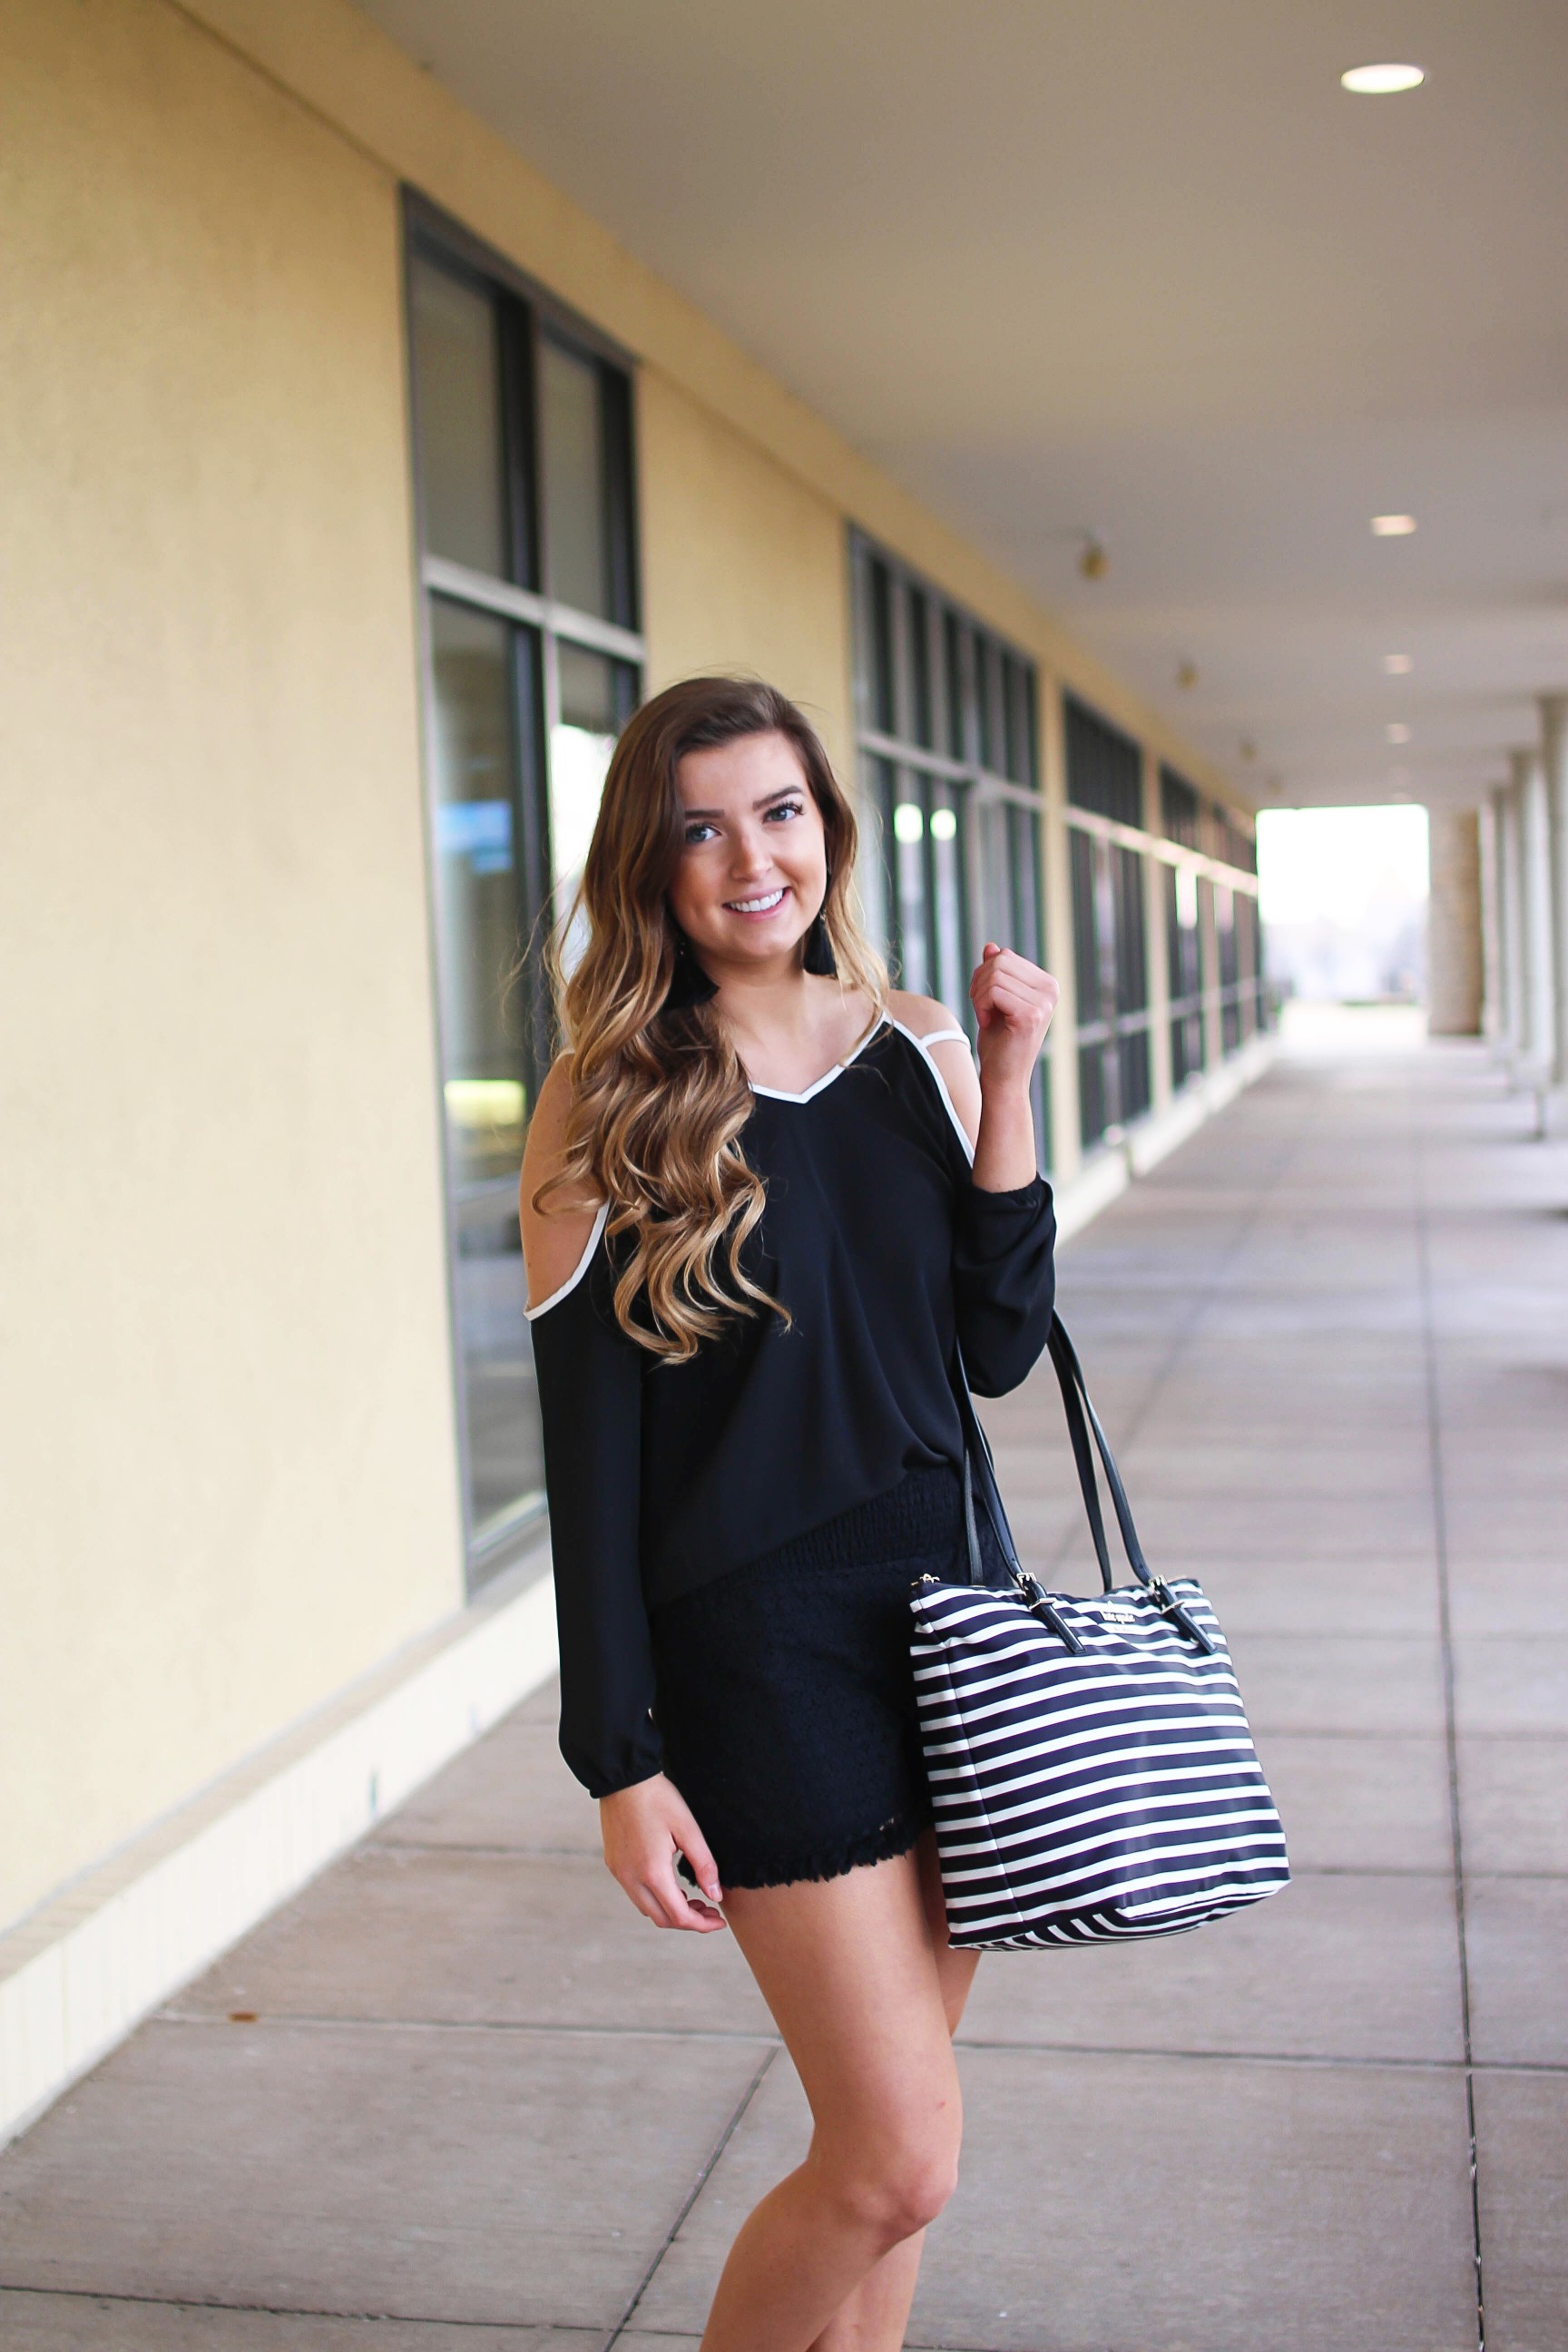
[910, 1318, 1290, 1947]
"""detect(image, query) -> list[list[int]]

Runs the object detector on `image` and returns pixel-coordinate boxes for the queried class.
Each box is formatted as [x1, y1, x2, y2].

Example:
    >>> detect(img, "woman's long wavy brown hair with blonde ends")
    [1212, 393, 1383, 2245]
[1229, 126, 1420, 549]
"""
[534, 677, 888, 1364]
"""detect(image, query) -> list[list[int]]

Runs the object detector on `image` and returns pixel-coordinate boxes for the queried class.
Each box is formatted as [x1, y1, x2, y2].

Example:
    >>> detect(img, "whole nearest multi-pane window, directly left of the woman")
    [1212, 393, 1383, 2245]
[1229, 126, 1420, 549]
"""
[409, 211, 640, 1583]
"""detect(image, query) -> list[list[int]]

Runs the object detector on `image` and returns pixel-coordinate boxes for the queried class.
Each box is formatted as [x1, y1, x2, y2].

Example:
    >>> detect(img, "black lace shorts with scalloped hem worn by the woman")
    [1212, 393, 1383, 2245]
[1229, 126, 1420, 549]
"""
[652, 1465, 995, 1886]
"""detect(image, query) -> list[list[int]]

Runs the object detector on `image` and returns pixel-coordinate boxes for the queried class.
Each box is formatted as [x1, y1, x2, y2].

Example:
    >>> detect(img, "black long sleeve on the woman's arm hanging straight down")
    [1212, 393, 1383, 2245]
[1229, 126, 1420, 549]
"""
[529, 1230, 663, 1797]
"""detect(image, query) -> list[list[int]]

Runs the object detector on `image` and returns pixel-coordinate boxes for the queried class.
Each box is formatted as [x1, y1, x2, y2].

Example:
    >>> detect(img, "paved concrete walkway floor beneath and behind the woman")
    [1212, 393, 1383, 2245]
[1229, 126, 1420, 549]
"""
[0, 1028, 1568, 2352]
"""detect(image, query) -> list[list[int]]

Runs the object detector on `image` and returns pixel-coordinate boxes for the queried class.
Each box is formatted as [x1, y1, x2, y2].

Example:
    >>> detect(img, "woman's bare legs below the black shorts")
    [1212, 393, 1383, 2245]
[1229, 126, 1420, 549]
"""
[703, 1853, 974, 2352]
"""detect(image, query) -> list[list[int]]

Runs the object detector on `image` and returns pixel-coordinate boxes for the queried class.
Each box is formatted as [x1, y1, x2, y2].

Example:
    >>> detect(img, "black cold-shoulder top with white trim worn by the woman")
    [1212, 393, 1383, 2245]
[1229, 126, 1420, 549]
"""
[529, 1021, 1055, 1797]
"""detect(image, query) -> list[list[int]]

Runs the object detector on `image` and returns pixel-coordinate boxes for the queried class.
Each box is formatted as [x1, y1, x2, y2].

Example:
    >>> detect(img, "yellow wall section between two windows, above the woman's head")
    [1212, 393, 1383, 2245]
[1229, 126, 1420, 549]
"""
[637, 369, 853, 786]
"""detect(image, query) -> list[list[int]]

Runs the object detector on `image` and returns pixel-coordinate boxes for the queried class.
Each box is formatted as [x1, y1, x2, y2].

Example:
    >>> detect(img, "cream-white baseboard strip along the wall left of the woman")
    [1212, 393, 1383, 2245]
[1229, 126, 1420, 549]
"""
[0, 1545, 554, 2145]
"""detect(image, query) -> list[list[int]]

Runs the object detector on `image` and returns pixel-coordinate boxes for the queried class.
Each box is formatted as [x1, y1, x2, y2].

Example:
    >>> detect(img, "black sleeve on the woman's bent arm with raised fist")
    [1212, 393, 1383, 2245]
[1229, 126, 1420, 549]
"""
[952, 1176, 1055, 1397]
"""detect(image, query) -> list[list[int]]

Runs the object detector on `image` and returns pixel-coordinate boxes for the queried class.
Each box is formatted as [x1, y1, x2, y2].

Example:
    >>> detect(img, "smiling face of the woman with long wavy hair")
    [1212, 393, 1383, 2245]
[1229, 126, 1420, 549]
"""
[670, 734, 828, 978]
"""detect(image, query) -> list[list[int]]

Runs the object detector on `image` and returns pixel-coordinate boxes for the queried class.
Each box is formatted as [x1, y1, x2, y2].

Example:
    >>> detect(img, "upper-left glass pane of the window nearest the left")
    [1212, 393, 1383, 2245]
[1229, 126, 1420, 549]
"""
[409, 254, 508, 579]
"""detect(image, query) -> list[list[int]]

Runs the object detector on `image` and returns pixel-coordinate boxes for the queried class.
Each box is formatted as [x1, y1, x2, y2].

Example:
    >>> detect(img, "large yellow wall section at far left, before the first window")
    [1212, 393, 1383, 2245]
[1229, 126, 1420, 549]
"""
[0, 0, 461, 1922]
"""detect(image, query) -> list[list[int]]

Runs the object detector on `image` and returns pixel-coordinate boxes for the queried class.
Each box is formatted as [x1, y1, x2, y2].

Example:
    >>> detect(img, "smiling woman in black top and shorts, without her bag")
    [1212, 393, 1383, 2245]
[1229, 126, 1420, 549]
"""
[522, 677, 1055, 2352]
